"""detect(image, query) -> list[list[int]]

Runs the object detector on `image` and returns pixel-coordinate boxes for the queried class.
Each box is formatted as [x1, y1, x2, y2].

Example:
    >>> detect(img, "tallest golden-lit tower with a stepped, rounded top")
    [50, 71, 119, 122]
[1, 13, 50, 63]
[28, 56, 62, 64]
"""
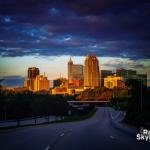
[84, 55, 100, 88]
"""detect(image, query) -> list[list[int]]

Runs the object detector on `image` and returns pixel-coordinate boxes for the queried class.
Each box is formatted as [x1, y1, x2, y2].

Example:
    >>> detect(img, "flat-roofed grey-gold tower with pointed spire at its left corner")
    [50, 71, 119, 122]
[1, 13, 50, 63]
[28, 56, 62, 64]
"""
[68, 58, 83, 84]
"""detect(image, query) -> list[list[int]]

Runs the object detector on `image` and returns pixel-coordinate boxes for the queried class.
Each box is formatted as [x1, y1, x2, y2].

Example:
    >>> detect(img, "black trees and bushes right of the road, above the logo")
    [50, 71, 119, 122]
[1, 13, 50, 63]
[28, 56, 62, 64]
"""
[110, 79, 150, 128]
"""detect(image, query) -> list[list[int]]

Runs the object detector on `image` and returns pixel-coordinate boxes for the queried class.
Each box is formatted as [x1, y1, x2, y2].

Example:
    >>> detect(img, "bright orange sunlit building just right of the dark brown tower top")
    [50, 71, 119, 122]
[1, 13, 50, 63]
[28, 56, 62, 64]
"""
[34, 75, 49, 91]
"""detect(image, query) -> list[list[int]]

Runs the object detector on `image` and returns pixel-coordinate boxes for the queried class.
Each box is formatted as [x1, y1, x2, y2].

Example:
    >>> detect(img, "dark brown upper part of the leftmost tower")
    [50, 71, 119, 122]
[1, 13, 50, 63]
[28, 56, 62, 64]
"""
[28, 67, 40, 79]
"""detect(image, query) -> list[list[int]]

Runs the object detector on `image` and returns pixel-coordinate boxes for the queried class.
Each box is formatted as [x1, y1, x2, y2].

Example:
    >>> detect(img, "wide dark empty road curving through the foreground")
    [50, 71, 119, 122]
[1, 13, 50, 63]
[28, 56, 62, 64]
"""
[0, 107, 150, 150]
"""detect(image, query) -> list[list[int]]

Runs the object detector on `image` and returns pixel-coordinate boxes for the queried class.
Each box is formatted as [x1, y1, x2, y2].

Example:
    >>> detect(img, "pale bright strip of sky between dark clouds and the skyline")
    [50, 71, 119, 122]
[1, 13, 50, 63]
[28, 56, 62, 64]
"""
[0, 56, 150, 79]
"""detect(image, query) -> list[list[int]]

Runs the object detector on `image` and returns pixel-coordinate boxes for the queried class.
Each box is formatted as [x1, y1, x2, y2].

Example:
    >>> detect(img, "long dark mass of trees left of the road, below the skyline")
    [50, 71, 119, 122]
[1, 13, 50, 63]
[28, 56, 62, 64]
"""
[0, 90, 70, 120]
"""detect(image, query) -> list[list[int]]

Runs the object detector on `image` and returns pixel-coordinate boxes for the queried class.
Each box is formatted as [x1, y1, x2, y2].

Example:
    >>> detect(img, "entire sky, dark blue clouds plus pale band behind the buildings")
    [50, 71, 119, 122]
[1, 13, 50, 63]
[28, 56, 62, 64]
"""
[0, 0, 150, 84]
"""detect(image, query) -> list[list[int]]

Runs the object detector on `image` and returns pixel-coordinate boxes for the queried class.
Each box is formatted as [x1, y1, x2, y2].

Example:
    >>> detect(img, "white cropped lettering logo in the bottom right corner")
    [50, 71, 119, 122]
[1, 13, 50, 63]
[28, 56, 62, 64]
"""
[136, 128, 150, 142]
